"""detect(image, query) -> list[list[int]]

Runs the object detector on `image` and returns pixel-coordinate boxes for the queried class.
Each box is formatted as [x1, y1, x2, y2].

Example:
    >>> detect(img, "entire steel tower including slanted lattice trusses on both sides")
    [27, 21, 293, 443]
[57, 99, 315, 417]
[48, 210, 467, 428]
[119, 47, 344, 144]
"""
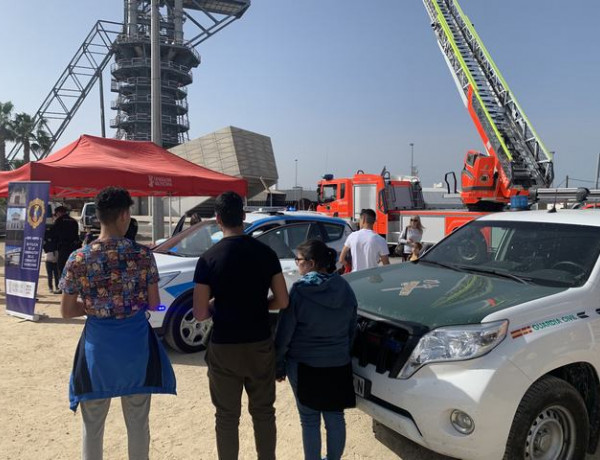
[7, 0, 251, 160]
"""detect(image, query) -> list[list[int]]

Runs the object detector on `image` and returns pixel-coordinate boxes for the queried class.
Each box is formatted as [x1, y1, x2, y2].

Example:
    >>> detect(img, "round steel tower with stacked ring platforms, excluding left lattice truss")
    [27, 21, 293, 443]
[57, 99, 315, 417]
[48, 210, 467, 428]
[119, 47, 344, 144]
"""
[110, 0, 250, 148]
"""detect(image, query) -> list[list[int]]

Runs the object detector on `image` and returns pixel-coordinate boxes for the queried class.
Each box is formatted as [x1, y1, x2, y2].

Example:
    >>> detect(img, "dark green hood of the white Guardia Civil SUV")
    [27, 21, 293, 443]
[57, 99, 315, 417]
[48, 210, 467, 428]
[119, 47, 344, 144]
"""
[346, 263, 567, 329]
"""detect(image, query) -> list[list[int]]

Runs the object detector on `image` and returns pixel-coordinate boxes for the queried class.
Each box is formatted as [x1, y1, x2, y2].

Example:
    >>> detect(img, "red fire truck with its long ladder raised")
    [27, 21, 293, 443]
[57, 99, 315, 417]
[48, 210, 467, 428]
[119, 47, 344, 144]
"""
[317, 0, 554, 248]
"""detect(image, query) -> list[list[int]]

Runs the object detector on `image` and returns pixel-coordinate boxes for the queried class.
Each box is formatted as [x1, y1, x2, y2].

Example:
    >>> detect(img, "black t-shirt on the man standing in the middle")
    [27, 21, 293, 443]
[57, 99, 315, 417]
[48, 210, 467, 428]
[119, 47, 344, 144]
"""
[194, 235, 281, 343]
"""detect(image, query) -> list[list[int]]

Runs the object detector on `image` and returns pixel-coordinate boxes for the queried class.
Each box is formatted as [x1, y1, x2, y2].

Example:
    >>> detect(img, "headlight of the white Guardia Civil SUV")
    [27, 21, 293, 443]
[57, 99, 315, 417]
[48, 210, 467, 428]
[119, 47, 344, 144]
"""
[398, 320, 508, 379]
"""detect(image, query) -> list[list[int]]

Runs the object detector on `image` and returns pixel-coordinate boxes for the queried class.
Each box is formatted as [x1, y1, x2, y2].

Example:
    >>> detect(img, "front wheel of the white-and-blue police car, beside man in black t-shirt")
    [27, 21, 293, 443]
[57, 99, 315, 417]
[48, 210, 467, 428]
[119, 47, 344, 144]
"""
[165, 299, 212, 353]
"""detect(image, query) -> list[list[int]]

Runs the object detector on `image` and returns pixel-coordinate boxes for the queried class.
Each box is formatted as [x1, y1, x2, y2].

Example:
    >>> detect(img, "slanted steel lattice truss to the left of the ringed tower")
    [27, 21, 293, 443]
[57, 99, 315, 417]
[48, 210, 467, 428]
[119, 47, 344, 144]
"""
[7, 21, 123, 164]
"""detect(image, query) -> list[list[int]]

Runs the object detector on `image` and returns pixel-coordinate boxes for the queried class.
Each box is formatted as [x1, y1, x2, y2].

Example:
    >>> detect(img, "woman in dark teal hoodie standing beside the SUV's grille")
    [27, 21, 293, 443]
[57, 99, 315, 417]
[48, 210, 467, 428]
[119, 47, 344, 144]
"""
[275, 240, 357, 460]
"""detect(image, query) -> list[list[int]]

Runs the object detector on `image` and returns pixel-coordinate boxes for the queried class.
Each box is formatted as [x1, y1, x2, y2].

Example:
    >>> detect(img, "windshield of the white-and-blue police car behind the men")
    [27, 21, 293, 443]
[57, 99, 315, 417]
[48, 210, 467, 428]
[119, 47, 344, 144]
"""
[154, 219, 250, 257]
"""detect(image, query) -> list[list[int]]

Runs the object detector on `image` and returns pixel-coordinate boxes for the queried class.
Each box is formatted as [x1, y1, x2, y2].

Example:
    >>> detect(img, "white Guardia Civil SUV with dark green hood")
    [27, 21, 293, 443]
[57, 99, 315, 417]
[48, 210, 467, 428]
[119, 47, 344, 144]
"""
[347, 210, 600, 460]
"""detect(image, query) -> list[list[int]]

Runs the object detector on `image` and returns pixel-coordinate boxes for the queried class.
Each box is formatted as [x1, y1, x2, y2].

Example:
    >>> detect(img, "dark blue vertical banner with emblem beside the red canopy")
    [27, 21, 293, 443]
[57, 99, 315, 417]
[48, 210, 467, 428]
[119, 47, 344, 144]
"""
[4, 182, 50, 321]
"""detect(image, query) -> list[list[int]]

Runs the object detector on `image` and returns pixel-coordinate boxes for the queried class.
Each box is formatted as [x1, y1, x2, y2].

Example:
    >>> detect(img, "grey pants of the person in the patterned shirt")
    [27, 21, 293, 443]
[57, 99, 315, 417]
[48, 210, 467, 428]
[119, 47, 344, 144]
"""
[81, 394, 151, 460]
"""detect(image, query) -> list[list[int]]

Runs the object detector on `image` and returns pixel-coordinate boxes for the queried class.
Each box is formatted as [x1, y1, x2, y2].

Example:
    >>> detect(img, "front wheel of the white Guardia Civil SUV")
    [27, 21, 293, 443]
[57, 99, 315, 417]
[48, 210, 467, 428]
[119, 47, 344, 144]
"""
[504, 376, 589, 460]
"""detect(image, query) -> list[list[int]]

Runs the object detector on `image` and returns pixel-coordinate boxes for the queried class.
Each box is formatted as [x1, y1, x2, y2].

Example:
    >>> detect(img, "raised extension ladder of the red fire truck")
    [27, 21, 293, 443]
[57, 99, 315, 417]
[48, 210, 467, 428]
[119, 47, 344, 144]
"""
[423, 0, 554, 188]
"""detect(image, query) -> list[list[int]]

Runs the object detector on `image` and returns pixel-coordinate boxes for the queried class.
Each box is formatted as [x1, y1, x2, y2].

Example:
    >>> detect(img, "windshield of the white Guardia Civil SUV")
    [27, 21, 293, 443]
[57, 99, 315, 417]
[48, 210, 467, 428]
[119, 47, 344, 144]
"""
[419, 221, 600, 287]
